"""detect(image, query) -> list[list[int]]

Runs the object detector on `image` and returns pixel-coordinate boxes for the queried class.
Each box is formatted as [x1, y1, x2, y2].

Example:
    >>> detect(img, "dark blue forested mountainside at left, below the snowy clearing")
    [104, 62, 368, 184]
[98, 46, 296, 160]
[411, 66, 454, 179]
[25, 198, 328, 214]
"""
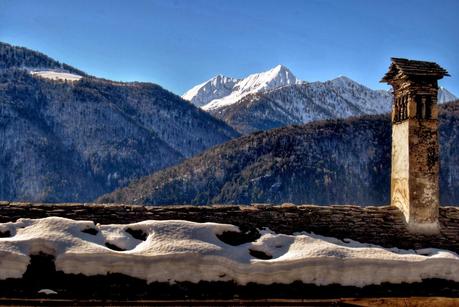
[0, 42, 238, 202]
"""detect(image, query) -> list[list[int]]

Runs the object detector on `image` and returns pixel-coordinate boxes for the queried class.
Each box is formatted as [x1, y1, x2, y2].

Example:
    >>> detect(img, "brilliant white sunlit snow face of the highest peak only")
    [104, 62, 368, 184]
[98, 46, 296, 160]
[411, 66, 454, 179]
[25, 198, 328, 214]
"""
[202, 65, 301, 111]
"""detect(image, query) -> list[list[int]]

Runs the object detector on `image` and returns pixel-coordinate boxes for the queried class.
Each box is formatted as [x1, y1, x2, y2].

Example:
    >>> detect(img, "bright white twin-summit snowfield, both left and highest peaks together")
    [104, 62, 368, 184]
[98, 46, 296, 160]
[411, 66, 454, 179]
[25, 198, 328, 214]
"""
[182, 65, 301, 110]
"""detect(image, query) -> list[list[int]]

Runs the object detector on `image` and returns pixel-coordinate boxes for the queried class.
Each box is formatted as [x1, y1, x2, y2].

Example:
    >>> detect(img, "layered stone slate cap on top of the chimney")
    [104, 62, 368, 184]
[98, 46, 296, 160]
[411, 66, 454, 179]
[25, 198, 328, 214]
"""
[381, 58, 449, 82]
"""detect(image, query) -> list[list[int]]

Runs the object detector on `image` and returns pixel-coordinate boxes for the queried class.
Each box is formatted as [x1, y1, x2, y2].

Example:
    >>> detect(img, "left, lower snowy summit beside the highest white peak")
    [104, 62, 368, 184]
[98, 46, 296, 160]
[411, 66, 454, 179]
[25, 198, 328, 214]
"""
[182, 75, 239, 107]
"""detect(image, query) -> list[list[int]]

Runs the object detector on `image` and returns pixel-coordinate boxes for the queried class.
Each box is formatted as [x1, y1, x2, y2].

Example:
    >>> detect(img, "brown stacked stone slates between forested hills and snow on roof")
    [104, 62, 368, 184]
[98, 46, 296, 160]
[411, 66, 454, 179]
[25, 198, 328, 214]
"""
[0, 202, 459, 253]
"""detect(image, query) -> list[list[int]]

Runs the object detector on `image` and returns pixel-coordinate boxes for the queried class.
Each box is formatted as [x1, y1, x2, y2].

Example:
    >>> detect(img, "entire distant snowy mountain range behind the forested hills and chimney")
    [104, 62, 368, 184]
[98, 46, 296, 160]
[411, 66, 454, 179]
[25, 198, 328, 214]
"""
[183, 65, 457, 134]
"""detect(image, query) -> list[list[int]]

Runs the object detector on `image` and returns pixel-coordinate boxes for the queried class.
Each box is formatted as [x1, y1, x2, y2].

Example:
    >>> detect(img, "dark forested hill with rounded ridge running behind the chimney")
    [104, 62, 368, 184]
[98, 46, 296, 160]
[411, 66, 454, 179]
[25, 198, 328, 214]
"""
[98, 101, 459, 205]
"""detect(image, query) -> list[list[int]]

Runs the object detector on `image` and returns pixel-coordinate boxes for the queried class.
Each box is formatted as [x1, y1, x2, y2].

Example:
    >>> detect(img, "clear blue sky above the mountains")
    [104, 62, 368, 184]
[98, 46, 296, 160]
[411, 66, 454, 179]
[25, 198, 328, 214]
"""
[0, 0, 459, 96]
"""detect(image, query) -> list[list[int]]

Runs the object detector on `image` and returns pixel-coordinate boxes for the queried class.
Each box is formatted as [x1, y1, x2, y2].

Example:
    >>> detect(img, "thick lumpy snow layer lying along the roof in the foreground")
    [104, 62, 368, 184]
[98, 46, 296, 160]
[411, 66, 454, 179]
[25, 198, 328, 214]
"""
[0, 217, 459, 286]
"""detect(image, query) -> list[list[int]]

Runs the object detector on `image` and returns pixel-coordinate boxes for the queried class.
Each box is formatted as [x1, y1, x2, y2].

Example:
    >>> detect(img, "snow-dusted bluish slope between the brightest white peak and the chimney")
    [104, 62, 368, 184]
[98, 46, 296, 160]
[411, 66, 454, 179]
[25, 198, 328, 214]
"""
[211, 77, 391, 134]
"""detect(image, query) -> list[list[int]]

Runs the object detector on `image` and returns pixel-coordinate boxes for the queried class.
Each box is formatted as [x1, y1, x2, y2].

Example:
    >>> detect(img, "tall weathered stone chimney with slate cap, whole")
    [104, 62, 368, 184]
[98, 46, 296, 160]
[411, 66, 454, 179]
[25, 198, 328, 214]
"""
[381, 58, 449, 234]
